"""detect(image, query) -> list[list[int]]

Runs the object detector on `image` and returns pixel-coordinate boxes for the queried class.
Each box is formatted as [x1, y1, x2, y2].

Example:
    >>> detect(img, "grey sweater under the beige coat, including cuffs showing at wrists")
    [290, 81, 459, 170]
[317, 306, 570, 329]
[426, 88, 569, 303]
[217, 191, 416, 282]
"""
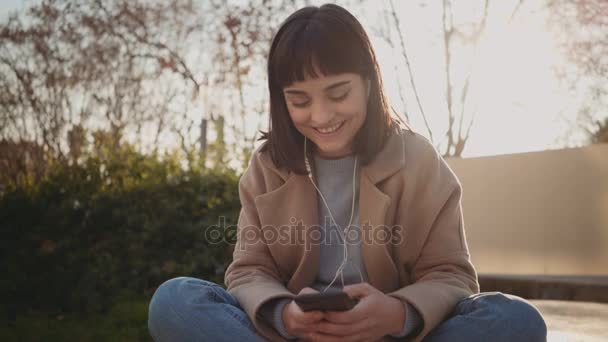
[261, 155, 422, 339]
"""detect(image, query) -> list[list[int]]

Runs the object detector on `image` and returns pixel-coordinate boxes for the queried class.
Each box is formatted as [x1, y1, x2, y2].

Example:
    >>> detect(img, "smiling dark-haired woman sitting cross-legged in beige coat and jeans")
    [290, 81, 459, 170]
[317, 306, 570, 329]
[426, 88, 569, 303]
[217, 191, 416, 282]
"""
[148, 5, 546, 342]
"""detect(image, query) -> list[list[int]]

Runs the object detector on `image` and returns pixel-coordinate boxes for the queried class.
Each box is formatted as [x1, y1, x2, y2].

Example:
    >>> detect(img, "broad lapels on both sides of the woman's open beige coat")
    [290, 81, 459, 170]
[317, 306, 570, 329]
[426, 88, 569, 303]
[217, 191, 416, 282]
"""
[255, 131, 405, 293]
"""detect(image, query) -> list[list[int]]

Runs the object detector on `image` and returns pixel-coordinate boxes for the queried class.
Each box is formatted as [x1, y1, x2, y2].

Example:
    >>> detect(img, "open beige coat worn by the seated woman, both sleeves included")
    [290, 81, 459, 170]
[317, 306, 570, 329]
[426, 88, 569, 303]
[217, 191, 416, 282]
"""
[225, 130, 479, 341]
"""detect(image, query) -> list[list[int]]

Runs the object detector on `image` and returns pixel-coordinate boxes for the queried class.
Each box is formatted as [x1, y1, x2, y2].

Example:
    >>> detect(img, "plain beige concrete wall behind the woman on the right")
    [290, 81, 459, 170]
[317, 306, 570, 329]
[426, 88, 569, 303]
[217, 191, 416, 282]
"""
[447, 144, 608, 276]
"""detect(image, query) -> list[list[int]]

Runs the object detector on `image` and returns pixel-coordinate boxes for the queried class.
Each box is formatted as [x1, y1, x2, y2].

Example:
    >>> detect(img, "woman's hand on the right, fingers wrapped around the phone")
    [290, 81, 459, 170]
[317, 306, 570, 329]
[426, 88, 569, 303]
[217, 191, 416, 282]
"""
[311, 283, 405, 342]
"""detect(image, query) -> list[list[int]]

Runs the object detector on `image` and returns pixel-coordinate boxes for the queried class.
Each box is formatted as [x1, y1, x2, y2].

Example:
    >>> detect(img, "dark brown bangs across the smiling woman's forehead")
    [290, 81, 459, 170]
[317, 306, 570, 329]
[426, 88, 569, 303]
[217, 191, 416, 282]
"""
[268, 17, 371, 88]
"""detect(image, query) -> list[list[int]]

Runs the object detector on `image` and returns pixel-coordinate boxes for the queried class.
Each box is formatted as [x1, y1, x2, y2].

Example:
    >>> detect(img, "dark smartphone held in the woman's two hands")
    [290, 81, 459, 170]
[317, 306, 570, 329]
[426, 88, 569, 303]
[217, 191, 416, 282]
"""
[294, 289, 359, 311]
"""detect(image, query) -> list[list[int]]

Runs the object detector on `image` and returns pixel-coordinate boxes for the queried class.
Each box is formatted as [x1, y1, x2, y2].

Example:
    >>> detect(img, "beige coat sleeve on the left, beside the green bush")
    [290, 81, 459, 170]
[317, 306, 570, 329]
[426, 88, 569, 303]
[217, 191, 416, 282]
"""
[224, 154, 295, 341]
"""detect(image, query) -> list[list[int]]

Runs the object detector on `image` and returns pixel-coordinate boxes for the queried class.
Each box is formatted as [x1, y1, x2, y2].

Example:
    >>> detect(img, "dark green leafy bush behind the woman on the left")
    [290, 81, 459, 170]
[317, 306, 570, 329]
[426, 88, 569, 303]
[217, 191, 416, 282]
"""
[0, 146, 240, 317]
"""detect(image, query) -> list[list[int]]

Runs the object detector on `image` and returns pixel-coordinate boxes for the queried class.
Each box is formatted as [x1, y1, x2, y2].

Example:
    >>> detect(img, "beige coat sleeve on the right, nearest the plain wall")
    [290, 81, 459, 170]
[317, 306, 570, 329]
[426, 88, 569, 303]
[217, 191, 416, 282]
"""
[387, 138, 479, 340]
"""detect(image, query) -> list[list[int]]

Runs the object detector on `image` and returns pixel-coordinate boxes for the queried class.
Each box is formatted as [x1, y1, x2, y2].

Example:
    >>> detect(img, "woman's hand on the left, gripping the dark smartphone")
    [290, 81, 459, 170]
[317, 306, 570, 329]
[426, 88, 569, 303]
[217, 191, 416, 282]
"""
[283, 287, 323, 340]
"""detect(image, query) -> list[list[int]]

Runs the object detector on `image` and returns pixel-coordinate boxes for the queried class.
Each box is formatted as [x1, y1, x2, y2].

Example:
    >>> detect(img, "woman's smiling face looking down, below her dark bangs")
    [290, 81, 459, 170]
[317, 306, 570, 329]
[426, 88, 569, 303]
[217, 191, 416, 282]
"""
[283, 73, 369, 158]
